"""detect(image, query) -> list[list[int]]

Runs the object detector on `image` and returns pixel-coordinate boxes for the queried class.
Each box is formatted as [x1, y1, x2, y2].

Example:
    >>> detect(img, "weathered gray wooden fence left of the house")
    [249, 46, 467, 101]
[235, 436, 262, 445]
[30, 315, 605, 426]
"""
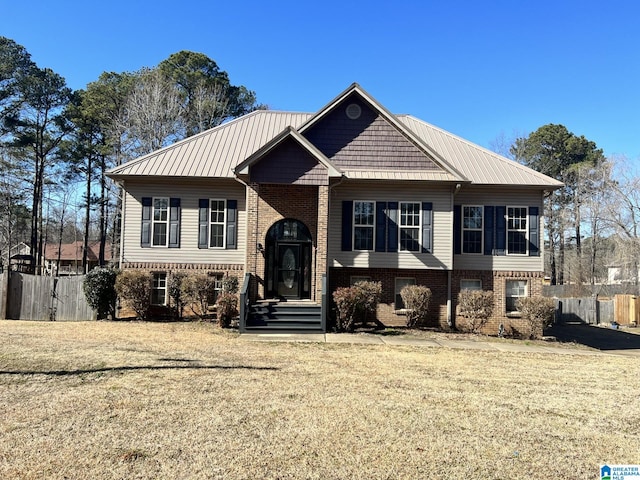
[0, 272, 96, 321]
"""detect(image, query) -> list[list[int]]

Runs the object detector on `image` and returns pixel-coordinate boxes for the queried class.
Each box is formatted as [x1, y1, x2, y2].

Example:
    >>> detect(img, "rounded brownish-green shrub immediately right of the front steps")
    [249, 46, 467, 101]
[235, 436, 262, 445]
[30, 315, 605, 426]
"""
[333, 282, 382, 332]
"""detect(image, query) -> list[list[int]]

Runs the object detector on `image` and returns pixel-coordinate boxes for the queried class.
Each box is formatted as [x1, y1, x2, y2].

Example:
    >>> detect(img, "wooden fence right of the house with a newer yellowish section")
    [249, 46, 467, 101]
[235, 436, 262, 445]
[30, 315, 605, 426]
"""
[556, 295, 640, 325]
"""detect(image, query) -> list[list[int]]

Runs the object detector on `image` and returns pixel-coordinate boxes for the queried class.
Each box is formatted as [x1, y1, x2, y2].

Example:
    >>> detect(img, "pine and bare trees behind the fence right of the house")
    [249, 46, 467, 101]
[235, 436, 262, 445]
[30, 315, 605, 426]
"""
[500, 124, 640, 285]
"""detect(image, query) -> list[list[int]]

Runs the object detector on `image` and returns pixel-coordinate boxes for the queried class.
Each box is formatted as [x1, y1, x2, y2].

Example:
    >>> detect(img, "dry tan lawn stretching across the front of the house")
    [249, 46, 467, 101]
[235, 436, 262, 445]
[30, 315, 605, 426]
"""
[0, 321, 640, 479]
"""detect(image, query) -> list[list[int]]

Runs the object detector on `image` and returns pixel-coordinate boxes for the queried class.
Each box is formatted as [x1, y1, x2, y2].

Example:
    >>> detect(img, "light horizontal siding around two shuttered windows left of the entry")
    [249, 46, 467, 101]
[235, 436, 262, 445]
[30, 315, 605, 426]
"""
[122, 179, 247, 264]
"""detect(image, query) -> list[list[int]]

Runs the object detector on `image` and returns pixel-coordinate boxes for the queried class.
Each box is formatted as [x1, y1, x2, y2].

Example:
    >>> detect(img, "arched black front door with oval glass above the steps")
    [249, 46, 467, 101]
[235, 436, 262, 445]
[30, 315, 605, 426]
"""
[265, 218, 312, 300]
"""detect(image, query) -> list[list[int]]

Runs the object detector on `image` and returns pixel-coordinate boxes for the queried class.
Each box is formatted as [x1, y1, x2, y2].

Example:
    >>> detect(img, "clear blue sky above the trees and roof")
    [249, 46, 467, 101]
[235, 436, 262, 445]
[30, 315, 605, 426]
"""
[0, 0, 640, 164]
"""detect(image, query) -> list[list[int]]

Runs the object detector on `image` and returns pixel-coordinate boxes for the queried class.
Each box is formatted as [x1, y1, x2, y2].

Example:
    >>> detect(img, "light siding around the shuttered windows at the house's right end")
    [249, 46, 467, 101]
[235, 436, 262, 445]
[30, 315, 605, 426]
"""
[454, 186, 544, 272]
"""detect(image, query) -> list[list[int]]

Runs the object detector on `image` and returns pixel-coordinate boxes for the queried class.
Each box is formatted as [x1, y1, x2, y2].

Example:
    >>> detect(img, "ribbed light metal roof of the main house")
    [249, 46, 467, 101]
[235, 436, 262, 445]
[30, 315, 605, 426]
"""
[108, 96, 562, 188]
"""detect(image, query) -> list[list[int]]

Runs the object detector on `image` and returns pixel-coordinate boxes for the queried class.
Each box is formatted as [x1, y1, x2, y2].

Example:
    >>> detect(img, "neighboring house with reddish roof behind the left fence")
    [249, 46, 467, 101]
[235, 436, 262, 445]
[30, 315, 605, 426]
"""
[44, 241, 111, 276]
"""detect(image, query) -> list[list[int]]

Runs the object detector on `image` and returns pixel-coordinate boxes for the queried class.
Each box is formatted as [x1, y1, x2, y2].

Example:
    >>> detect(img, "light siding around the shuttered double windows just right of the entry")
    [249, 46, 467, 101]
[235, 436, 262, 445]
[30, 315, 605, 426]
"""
[328, 182, 453, 269]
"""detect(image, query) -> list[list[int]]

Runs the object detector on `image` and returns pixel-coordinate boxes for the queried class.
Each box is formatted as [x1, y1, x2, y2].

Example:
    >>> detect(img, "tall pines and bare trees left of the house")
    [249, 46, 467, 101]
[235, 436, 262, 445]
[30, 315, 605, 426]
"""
[0, 37, 264, 273]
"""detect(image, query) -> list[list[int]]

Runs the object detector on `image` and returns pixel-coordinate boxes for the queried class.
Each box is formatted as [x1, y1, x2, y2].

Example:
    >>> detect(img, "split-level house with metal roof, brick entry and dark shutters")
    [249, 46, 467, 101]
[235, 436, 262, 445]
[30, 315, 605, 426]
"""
[108, 84, 562, 331]
